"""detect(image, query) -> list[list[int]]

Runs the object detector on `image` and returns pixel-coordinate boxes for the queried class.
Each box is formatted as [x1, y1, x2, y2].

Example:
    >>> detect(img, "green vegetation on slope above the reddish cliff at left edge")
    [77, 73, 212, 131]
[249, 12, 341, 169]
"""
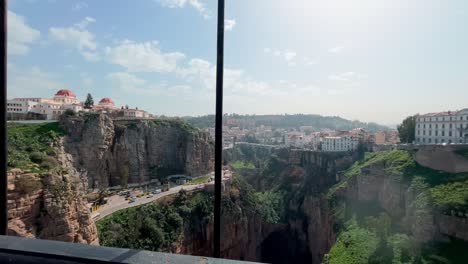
[7, 122, 64, 173]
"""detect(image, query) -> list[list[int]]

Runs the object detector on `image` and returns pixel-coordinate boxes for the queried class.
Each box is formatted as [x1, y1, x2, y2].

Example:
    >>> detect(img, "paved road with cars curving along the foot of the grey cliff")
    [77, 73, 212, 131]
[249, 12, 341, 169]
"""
[93, 184, 204, 221]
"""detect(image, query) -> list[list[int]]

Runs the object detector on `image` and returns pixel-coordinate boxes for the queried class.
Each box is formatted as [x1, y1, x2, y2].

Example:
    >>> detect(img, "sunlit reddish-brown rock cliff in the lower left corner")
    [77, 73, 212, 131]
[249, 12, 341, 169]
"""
[8, 170, 99, 244]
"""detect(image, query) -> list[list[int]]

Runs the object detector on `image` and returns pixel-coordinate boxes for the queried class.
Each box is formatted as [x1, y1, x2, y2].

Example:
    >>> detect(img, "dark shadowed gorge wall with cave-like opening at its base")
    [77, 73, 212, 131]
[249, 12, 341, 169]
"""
[180, 146, 356, 263]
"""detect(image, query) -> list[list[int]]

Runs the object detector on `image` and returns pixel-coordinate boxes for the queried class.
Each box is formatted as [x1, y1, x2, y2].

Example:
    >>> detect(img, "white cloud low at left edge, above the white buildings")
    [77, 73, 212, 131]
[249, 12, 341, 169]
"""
[7, 66, 64, 98]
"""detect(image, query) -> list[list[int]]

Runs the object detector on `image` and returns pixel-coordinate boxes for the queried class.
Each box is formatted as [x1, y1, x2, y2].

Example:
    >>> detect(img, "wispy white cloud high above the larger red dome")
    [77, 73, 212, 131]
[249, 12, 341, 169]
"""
[49, 17, 100, 62]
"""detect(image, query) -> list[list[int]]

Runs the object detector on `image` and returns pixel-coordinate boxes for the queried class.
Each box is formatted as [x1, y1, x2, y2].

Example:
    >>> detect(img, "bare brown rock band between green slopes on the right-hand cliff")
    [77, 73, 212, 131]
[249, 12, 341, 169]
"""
[341, 158, 468, 242]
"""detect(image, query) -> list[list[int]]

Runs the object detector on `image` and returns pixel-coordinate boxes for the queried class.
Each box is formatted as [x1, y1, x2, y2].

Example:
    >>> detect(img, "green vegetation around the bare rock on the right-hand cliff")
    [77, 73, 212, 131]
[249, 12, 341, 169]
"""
[324, 150, 468, 264]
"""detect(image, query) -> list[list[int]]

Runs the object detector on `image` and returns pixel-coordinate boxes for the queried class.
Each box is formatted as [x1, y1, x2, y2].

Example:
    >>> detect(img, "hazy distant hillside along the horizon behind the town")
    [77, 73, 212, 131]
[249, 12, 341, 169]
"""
[184, 114, 389, 131]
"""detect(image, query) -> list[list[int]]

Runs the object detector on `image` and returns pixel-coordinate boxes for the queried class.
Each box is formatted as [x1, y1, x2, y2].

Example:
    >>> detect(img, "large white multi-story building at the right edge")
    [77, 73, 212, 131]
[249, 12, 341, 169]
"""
[415, 108, 468, 144]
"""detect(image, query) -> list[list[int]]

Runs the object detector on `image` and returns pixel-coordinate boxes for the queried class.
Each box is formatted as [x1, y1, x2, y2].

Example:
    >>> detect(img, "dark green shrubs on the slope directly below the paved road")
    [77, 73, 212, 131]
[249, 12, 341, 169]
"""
[97, 191, 213, 252]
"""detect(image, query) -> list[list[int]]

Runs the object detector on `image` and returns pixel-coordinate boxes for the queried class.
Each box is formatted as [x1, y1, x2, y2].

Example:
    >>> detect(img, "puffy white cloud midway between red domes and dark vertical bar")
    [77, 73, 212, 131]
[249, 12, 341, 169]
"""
[105, 40, 185, 73]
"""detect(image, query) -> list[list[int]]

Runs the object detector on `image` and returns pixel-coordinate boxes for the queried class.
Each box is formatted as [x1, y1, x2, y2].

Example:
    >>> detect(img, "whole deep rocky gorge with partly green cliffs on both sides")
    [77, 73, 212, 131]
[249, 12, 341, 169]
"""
[8, 118, 468, 263]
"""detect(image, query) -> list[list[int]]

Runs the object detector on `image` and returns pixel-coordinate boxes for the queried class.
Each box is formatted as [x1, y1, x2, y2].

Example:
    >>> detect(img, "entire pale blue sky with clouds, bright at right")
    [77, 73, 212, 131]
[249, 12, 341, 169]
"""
[8, 0, 468, 124]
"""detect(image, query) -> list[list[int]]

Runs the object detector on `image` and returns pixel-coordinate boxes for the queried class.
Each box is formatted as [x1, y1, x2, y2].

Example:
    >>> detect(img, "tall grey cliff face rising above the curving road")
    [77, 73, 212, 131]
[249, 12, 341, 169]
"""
[61, 114, 214, 188]
